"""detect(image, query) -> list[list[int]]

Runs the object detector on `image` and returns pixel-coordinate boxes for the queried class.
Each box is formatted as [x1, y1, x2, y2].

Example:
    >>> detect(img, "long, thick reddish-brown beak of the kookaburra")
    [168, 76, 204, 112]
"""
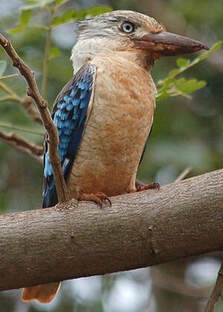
[131, 32, 209, 56]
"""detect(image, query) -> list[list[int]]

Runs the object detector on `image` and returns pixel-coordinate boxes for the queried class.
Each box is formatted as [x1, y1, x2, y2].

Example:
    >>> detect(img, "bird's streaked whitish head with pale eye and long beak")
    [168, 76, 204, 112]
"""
[71, 10, 208, 71]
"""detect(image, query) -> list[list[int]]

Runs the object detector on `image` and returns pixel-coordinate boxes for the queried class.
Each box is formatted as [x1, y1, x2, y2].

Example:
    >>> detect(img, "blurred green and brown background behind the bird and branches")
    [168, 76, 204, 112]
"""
[0, 0, 223, 312]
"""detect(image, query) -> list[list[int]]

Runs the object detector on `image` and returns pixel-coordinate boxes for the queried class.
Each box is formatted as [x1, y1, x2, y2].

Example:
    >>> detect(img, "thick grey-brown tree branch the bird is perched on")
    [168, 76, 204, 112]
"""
[0, 170, 223, 290]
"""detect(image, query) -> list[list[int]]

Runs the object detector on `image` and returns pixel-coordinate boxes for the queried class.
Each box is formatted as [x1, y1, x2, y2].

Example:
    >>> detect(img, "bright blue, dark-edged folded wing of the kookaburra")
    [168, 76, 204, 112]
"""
[43, 63, 96, 208]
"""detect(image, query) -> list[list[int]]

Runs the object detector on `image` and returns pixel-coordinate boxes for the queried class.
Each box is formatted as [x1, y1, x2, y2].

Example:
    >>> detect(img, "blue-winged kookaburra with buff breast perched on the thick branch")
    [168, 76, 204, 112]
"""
[22, 10, 208, 303]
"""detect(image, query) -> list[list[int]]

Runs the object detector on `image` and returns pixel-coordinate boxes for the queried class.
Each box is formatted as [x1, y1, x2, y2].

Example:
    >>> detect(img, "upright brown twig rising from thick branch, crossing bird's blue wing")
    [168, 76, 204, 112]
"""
[0, 34, 69, 201]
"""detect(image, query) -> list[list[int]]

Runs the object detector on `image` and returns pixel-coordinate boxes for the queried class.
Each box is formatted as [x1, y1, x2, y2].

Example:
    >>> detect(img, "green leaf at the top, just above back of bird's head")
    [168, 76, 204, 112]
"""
[51, 6, 112, 27]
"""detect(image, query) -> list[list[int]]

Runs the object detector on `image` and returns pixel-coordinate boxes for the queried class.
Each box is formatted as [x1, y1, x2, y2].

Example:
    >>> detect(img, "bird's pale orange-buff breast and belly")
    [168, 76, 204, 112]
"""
[68, 58, 155, 198]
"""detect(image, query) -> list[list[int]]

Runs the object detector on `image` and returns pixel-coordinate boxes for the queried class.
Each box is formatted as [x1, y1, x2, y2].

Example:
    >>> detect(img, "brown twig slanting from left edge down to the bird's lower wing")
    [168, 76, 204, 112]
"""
[0, 131, 43, 164]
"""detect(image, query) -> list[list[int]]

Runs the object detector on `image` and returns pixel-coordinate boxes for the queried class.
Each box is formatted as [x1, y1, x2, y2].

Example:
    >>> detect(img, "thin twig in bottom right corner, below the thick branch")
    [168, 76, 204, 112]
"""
[205, 264, 223, 312]
